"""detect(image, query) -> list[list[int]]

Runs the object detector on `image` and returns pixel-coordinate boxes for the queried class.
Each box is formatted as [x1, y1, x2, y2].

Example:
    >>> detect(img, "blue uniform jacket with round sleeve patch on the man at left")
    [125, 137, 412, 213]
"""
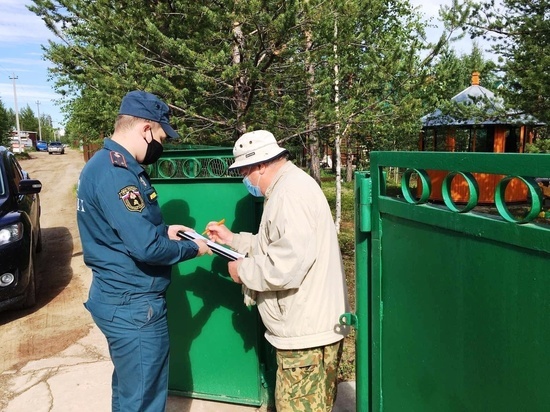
[77, 139, 198, 310]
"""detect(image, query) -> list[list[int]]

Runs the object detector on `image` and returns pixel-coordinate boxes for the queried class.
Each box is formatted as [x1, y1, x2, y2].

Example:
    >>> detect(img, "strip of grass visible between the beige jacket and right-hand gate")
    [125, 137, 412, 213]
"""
[321, 172, 355, 382]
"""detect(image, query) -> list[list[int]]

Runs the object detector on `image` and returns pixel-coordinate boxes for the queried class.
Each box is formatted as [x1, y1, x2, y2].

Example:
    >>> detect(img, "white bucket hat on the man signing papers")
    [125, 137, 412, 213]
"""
[229, 130, 287, 170]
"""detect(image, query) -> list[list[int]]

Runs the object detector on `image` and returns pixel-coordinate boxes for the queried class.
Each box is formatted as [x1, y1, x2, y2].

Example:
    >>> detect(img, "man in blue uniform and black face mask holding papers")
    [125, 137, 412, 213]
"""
[77, 91, 212, 412]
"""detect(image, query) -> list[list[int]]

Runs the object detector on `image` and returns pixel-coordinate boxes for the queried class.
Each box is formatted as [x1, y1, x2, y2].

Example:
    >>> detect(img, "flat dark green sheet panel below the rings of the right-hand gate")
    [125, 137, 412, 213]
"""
[378, 219, 550, 412]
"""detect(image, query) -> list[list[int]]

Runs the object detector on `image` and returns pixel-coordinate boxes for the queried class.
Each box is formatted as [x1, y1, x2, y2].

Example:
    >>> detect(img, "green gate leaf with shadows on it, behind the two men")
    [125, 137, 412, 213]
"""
[148, 147, 275, 406]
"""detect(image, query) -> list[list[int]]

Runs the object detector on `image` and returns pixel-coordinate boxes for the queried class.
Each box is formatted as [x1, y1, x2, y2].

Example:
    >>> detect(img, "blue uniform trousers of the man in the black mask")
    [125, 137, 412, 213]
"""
[86, 296, 169, 412]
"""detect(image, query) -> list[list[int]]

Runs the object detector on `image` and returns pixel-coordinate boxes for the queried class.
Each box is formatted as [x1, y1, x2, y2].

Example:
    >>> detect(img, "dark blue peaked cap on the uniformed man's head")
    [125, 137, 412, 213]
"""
[118, 90, 180, 139]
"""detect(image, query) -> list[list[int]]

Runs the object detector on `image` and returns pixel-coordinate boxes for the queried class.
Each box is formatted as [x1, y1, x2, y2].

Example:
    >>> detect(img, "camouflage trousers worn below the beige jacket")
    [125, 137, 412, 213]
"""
[275, 340, 344, 412]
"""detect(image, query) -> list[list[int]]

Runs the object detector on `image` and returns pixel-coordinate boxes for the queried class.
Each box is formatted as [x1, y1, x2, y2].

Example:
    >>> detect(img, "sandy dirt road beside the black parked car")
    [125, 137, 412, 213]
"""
[0, 149, 97, 404]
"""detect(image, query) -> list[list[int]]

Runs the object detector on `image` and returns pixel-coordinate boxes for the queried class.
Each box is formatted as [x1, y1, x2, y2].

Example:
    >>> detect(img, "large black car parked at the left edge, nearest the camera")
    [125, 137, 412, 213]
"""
[0, 146, 42, 310]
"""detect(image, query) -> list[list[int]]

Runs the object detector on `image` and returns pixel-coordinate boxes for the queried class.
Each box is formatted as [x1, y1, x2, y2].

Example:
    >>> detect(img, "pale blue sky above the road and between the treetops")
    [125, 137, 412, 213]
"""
[0, 0, 492, 132]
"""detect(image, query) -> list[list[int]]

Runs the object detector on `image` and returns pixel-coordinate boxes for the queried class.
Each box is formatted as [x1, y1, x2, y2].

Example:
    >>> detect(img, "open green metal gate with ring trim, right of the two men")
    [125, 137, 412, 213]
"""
[352, 152, 550, 412]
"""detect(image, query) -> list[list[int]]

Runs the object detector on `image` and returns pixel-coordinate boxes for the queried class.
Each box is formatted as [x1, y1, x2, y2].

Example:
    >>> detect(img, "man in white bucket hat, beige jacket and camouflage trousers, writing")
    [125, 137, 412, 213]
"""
[206, 130, 349, 412]
